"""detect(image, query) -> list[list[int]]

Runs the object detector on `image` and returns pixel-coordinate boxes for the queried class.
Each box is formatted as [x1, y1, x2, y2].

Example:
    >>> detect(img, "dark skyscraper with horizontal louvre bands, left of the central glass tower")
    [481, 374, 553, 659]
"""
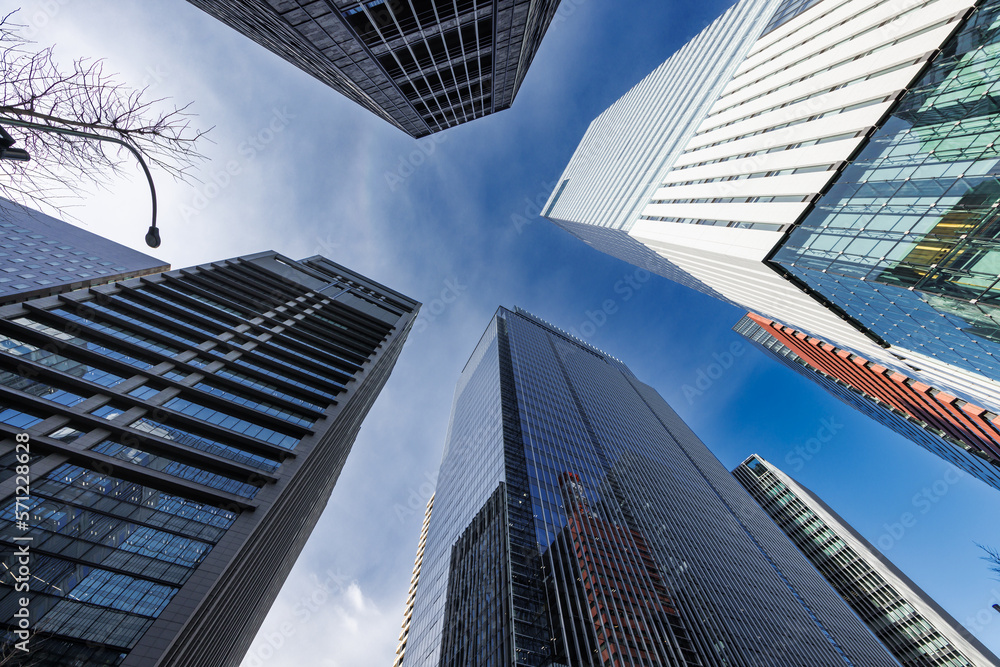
[0, 252, 418, 667]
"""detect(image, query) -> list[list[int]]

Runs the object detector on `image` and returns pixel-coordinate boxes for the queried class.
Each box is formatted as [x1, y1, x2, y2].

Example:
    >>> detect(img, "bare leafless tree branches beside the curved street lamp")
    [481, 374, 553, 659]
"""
[0, 13, 205, 217]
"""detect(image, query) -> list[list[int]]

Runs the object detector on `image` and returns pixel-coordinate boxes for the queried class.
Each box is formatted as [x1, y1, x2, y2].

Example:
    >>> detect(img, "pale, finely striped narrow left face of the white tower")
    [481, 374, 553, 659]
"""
[543, 0, 778, 232]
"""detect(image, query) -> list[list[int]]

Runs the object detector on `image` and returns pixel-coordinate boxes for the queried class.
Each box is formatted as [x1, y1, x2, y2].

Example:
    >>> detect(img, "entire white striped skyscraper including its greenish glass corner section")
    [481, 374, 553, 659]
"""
[543, 0, 1000, 418]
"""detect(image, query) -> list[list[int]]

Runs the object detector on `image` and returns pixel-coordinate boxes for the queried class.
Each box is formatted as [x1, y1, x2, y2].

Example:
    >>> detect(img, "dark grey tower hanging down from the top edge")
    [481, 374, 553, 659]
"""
[189, 0, 559, 137]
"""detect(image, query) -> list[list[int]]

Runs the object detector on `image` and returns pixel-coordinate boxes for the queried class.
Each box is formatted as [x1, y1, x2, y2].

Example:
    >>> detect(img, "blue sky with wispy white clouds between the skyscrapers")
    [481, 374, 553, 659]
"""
[18, 0, 1000, 667]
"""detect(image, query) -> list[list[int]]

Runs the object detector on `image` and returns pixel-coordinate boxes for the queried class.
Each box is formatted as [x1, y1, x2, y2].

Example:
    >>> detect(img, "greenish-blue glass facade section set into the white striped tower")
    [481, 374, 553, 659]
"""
[771, 0, 1000, 380]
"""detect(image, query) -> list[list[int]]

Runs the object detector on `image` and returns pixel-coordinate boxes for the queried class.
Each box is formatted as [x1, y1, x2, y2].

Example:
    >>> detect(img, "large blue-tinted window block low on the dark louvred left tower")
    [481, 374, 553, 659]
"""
[0, 464, 236, 664]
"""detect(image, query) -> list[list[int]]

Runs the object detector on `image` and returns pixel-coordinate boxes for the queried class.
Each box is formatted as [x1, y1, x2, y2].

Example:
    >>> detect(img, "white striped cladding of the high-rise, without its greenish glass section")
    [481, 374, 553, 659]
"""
[543, 0, 1000, 410]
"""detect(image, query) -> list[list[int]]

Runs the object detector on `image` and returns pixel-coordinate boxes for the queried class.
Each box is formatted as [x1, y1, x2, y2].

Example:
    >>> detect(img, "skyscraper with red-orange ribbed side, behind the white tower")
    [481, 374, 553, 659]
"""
[733, 315, 1000, 489]
